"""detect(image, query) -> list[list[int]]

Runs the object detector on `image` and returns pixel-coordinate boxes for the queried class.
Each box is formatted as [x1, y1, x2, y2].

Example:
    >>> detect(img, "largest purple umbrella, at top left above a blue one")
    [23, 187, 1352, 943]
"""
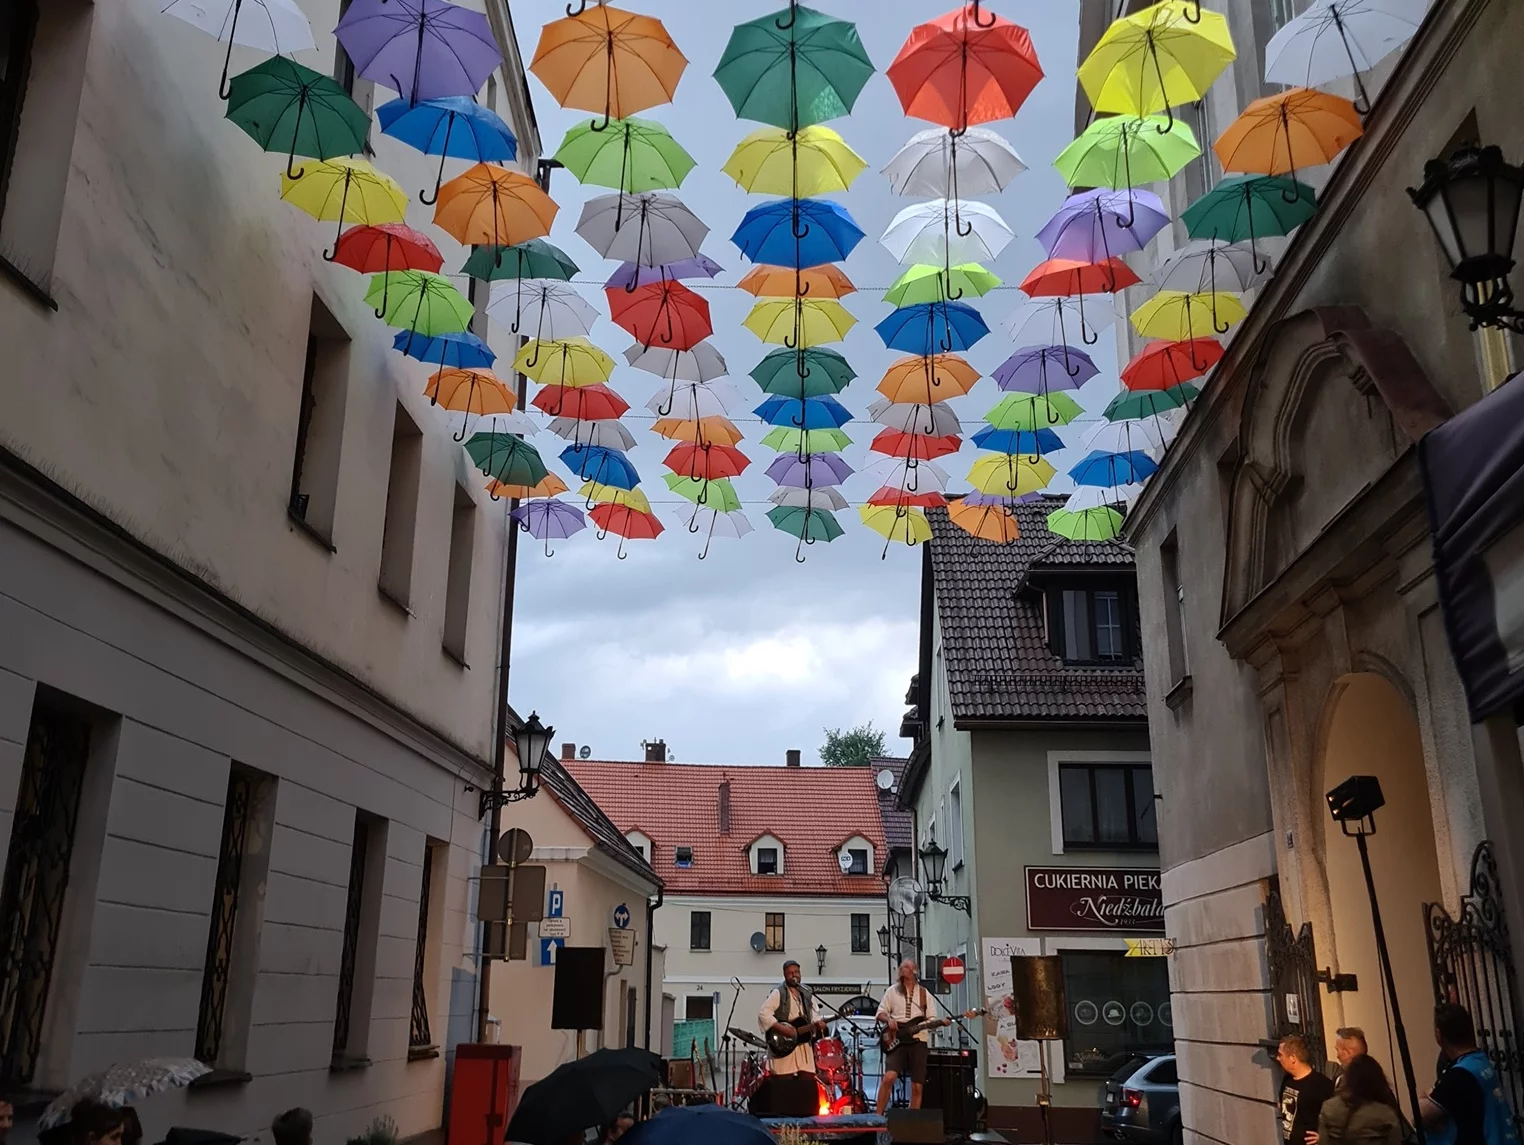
[334, 0, 503, 104]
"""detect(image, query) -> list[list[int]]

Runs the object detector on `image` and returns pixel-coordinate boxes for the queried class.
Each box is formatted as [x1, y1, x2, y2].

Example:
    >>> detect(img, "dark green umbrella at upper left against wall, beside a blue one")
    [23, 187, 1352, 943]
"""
[227, 56, 370, 178]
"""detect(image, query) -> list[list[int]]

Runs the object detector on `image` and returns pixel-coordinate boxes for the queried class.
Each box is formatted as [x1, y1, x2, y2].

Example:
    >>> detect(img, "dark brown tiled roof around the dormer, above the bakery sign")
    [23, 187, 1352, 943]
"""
[927, 499, 1146, 721]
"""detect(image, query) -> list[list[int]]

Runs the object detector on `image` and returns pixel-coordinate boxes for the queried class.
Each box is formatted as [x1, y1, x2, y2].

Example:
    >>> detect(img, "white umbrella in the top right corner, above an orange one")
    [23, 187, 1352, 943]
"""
[1265, 0, 1430, 114]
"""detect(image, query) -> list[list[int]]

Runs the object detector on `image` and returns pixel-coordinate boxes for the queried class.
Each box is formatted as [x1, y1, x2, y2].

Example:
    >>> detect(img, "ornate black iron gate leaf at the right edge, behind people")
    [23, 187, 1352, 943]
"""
[1423, 842, 1524, 1125]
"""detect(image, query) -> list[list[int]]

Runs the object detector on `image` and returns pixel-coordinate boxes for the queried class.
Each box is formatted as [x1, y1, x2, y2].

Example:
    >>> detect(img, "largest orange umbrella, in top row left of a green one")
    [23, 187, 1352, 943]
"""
[529, 0, 687, 131]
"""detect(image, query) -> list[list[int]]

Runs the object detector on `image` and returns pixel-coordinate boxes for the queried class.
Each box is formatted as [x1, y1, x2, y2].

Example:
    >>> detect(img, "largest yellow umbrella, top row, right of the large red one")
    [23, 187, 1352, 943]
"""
[1079, 0, 1237, 122]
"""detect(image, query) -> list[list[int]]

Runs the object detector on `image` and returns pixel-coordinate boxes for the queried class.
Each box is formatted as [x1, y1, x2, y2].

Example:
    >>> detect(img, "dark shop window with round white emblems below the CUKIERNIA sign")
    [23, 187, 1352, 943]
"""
[1061, 950, 1175, 1076]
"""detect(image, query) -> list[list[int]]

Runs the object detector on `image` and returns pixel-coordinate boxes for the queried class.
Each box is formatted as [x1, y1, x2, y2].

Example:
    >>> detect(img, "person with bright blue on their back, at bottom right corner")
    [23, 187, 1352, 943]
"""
[1419, 1002, 1519, 1145]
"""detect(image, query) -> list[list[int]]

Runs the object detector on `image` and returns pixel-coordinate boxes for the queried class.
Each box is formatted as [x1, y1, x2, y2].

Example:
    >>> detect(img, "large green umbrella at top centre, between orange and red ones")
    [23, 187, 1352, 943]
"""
[715, 3, 873, 131]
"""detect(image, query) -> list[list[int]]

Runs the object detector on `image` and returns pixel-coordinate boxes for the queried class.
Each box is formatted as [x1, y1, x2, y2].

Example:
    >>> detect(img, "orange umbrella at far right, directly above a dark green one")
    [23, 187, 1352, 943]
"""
[1213, 87, 1366, 184]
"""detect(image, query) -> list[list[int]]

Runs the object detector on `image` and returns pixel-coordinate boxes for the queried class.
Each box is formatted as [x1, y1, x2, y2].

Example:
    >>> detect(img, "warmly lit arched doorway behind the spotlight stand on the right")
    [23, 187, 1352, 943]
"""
[1320, 672, 1440, 1090]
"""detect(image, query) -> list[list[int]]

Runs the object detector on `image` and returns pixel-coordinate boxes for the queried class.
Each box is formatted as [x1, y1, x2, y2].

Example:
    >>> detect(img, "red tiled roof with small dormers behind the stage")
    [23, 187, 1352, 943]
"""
[564, 759, 887, 898]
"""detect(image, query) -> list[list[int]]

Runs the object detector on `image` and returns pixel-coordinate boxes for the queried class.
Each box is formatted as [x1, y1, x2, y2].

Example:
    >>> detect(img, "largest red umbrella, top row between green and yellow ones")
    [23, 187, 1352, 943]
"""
[888, 0, 1042, 134]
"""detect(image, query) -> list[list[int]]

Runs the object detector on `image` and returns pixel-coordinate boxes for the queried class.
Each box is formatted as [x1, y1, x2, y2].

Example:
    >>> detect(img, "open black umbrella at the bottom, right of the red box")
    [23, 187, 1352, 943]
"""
[503, 1047, 661, 1145]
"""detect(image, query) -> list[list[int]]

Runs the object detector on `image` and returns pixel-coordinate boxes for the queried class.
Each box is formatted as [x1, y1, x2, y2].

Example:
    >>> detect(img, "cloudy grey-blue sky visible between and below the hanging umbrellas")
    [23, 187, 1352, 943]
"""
[512, 0, 1116, 764]
